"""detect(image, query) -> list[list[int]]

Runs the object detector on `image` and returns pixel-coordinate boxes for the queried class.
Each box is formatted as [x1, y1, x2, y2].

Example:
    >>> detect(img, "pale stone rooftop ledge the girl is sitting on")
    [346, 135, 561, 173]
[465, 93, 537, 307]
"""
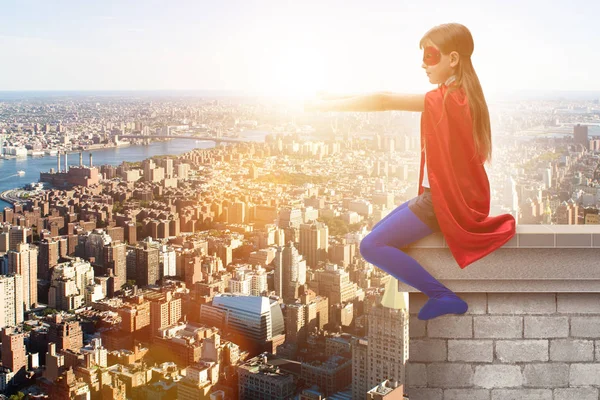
[400, 225, 600, 293]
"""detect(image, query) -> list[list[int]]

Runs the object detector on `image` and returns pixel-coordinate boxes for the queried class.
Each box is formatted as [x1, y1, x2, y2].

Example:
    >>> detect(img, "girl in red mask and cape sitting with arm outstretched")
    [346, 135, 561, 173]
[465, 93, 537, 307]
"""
[306, 23, 515, 320]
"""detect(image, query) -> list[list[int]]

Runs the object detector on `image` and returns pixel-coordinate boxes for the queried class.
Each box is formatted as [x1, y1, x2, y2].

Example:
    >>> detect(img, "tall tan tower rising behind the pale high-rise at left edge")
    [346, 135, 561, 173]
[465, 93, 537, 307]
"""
[7, 242, 38, 311]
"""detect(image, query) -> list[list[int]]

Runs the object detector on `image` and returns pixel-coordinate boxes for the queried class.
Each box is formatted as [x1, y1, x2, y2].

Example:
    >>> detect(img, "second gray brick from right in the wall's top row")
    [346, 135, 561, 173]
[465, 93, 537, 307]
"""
[488, 293, 556, 315]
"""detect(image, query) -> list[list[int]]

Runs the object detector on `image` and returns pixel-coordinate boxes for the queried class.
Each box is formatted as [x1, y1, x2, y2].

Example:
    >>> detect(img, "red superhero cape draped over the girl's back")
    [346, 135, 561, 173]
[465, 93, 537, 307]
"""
[419, 85, 516, 268]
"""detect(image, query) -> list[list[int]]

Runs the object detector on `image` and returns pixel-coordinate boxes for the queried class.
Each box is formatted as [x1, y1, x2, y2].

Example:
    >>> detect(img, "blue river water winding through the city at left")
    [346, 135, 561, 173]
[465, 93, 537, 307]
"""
[0, 131, 270, 210]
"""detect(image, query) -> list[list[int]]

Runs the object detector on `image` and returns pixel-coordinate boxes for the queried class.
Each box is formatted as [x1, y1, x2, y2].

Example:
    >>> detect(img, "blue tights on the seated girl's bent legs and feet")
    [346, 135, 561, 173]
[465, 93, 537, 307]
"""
[360, 201, 468, 319]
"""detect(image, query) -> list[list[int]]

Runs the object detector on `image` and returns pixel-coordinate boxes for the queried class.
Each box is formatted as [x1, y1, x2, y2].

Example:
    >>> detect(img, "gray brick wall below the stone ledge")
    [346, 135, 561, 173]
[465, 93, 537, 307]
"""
[405, 293, 600, 400]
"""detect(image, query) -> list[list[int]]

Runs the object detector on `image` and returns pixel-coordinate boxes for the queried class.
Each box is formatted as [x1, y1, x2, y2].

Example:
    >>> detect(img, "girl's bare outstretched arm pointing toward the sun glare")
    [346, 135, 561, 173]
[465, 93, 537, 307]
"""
[305, 92, 425, 112]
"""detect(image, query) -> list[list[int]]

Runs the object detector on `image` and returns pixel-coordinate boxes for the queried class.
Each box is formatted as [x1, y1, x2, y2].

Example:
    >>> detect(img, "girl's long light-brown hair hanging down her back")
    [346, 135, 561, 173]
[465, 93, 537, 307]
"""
[419, 23, 492, 162]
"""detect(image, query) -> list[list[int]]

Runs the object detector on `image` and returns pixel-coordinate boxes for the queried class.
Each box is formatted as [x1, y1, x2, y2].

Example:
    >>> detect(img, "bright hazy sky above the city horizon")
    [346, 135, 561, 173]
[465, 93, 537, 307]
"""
[0, 0, 600, 96]
